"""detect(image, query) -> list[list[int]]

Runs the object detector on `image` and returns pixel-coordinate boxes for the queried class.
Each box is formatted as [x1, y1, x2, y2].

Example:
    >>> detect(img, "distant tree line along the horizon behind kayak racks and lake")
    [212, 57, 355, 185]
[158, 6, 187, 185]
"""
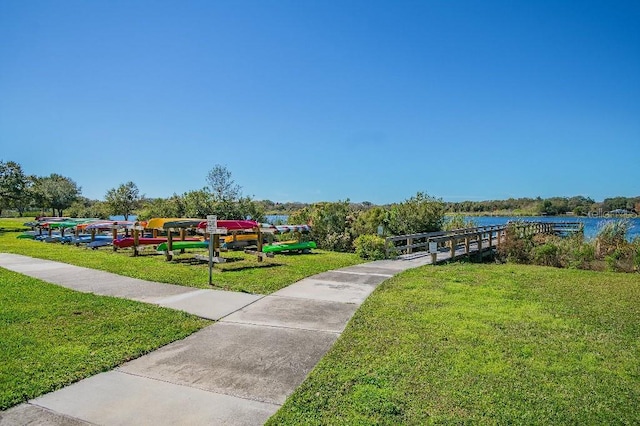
[0, 161, 640, 221]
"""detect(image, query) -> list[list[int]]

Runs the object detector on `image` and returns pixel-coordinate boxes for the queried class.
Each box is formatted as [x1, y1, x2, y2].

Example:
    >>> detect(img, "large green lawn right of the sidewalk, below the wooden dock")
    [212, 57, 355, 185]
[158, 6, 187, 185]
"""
[269, 264, 640, 425]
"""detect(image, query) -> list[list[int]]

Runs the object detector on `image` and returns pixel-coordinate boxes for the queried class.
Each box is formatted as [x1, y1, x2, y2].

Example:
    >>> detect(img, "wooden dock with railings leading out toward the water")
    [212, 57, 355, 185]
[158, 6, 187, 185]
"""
[385, 222, 583, 264]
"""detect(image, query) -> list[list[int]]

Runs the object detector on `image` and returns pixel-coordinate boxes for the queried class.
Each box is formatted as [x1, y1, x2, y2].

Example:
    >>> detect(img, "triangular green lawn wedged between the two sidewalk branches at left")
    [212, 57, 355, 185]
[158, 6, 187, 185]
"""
[0, 268, 210, 410]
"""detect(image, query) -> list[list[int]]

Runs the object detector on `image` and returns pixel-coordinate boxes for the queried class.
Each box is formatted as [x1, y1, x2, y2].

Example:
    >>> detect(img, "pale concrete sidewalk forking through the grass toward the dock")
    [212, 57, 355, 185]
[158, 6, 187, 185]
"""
[0, 254, 429, 425]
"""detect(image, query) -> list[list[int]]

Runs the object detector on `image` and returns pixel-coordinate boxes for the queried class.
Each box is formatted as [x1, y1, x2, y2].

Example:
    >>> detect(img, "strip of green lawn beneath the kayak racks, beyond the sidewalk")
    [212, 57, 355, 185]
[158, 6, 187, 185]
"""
[0, 225, 362, 294]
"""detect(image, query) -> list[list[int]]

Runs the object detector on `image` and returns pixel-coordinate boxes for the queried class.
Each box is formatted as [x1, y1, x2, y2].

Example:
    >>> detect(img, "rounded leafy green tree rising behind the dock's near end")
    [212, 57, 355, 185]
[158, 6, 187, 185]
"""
[389, 192, 445, 235]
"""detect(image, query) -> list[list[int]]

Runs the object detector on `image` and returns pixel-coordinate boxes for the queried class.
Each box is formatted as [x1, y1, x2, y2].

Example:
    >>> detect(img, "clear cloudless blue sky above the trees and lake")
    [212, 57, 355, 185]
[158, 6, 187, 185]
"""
[0, 0, 640, 204]
